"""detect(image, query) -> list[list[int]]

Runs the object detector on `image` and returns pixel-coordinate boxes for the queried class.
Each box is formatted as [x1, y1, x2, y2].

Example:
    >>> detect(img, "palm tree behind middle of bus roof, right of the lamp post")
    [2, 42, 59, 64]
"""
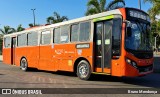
[46, 12, 68, 24]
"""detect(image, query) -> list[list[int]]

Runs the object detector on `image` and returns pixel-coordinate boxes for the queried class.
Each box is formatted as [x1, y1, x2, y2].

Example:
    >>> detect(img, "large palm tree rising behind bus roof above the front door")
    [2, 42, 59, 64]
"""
[85, 0, 125, 15]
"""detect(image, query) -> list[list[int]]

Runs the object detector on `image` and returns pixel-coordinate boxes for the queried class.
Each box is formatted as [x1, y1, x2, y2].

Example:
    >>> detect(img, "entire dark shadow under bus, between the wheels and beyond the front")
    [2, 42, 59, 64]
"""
[25, 69, 160, 88]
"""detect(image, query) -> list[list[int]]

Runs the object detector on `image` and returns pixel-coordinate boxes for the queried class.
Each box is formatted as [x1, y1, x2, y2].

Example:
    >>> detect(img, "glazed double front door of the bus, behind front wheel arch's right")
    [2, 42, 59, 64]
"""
[94, 19, 113, 74]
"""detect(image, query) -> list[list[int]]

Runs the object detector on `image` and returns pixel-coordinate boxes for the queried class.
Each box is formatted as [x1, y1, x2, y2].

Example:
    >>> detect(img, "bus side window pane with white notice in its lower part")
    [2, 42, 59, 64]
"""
[60, 26, 69, 43]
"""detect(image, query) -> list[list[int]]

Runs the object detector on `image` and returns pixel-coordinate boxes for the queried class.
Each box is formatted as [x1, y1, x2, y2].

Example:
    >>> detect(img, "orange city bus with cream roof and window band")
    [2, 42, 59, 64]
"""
[3, 8, 153, 80]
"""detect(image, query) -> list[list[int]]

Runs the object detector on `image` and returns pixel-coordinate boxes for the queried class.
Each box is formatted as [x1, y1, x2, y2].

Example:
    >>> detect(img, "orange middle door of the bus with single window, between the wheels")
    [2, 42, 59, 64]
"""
[38, 29, 54, 70]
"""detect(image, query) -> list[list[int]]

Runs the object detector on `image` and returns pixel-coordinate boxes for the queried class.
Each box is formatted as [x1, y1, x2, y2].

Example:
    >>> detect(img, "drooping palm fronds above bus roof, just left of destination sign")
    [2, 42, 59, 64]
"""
[107, 0, 126, 10]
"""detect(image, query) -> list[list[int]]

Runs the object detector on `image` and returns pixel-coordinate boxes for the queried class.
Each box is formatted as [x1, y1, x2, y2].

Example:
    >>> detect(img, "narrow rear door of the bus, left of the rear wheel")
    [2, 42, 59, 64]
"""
[11, 37, 16, 65]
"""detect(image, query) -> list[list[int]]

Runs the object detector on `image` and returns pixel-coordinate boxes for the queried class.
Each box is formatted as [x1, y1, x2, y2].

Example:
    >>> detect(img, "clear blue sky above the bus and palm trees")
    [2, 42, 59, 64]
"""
[0, 0, 151, 28]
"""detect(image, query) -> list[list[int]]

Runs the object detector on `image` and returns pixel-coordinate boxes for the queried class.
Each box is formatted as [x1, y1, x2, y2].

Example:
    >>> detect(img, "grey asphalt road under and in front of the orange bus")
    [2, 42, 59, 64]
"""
[0, 59, 160, 97]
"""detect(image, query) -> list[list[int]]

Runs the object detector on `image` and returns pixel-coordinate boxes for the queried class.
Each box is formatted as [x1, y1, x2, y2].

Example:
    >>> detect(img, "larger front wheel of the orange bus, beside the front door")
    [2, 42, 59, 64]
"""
[77, 60, 91, 80]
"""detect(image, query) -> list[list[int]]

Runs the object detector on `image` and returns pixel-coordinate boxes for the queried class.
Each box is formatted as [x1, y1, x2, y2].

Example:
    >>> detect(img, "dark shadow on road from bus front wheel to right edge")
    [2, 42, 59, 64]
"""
[91, 73, 160, 88]
